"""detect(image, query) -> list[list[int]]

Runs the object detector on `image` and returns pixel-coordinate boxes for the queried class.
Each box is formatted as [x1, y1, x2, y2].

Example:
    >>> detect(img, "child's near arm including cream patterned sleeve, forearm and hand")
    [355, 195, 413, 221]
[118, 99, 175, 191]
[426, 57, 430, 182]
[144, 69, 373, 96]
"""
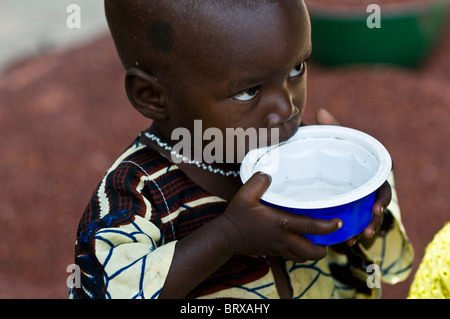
[71, 170, 339, 298]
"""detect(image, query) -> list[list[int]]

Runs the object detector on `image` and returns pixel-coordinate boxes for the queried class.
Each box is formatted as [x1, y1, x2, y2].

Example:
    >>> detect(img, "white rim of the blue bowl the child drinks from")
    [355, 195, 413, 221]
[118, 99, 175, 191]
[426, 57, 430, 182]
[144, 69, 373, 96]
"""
[240, 125, 392, 209]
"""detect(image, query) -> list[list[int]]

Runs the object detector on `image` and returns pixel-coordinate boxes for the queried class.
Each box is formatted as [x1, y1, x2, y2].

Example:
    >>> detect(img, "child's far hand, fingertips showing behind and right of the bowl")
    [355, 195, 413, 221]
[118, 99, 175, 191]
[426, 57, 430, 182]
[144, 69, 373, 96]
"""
[316, 109, 392, 246]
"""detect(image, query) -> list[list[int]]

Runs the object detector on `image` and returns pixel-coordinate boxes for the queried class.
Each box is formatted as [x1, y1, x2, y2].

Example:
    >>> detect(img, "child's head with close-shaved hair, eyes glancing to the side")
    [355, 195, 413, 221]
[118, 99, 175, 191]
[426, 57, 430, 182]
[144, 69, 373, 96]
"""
[105, 0, 311, 149]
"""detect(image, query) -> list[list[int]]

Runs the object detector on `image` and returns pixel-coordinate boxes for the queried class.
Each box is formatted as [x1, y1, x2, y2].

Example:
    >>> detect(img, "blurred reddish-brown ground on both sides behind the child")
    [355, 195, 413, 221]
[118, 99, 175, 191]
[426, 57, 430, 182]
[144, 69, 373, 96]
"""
[0, 21, 450, 298]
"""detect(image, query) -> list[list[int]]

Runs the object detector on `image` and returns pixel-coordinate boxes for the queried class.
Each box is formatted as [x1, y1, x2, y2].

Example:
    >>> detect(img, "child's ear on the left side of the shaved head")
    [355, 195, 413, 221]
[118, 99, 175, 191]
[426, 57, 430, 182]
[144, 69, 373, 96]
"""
[125, 68, 168, 120]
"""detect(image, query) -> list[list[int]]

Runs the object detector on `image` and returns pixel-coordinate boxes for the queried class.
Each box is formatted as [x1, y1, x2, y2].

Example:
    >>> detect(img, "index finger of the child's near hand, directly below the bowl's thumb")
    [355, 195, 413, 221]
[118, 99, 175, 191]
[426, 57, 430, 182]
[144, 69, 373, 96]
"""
[280, 214, 343, 235]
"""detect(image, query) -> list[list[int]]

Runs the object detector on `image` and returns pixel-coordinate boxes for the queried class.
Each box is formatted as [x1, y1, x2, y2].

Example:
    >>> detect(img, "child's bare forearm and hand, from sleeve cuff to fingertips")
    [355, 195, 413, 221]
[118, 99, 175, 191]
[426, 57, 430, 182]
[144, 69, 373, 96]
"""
[160, 173, 342, 298]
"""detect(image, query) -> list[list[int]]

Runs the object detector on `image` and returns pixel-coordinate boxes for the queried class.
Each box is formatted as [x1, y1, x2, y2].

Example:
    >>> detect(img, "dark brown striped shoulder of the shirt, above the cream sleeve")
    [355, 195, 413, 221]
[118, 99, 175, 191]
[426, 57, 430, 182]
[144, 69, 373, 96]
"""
[79, 132, 226, 235]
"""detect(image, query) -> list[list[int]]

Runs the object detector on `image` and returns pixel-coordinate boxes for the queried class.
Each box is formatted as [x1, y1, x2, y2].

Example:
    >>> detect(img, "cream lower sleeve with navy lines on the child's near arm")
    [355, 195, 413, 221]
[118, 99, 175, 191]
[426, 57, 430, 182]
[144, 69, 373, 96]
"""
[70, 211, 176, 299]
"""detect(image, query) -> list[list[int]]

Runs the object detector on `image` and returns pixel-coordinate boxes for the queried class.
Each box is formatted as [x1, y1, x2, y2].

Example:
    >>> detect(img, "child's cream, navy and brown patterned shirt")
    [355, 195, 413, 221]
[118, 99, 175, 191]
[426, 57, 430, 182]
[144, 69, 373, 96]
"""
[69, 136, 413, 299]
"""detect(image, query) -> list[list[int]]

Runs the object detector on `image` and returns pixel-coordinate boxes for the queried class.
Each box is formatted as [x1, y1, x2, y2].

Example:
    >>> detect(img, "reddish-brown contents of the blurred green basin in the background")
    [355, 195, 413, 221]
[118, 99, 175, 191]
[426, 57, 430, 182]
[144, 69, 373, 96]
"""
[306, 0, 450, 21]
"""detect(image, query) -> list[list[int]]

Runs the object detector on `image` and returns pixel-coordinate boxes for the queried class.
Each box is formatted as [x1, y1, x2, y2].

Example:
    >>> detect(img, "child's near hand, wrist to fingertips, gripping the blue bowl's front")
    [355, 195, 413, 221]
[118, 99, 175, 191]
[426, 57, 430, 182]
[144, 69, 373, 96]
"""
[220, 173, 342, 262]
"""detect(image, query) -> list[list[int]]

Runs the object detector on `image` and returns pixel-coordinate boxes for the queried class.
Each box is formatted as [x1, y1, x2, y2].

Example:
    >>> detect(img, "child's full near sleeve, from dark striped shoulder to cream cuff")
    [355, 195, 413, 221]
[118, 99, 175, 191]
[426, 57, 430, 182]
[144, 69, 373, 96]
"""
[69, 143, 181, 299]
